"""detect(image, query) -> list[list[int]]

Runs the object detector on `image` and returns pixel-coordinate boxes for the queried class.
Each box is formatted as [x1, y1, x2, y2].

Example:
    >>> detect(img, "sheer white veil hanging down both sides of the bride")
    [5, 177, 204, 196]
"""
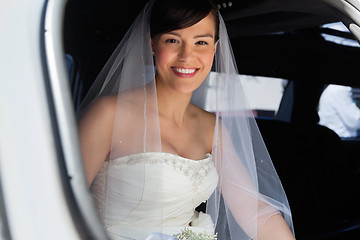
[79, 1, 293, 240]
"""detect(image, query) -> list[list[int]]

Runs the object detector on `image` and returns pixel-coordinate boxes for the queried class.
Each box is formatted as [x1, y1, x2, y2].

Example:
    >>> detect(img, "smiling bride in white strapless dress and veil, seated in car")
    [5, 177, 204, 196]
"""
[79, 0, 294, 240]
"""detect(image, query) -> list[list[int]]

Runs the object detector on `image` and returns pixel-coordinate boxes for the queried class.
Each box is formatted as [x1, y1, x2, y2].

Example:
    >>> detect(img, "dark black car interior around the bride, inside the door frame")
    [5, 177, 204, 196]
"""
[64, 0, 360, 239]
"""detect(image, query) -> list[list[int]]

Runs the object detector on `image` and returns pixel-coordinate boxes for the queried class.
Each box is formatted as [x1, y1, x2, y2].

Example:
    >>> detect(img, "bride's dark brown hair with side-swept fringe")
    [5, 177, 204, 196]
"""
[150, 0, 219, 41]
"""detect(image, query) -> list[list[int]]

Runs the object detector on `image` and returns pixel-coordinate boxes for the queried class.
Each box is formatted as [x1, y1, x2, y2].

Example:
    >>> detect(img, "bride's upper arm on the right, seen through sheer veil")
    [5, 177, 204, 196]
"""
[215, 120, 276, 236]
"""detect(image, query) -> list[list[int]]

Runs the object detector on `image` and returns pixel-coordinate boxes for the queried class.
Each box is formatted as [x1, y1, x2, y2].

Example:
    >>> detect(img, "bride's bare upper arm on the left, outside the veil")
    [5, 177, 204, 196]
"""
[78, 97, 116, 185]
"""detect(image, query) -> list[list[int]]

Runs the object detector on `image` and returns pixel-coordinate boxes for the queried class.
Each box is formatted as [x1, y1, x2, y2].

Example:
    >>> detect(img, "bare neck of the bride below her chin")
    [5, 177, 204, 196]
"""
[156, 78, 192, 126]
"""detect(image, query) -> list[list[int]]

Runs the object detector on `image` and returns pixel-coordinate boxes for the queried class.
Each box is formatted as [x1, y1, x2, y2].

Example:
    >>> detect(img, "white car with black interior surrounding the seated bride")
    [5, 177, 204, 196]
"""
[0, 0, 360, 240]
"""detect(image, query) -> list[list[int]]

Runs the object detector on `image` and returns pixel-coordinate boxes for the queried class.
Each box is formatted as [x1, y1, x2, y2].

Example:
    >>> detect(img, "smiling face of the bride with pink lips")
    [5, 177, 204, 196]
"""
[152, 14, 216, 93]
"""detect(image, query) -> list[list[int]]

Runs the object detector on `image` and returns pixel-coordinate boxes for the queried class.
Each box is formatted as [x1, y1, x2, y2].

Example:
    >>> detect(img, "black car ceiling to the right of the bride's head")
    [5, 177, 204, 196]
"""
[218, 0, 337, 37]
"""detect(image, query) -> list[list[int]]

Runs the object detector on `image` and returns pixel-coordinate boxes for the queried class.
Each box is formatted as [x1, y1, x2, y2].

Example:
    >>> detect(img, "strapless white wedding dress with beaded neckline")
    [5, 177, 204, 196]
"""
[91, 152, 218, 240]
